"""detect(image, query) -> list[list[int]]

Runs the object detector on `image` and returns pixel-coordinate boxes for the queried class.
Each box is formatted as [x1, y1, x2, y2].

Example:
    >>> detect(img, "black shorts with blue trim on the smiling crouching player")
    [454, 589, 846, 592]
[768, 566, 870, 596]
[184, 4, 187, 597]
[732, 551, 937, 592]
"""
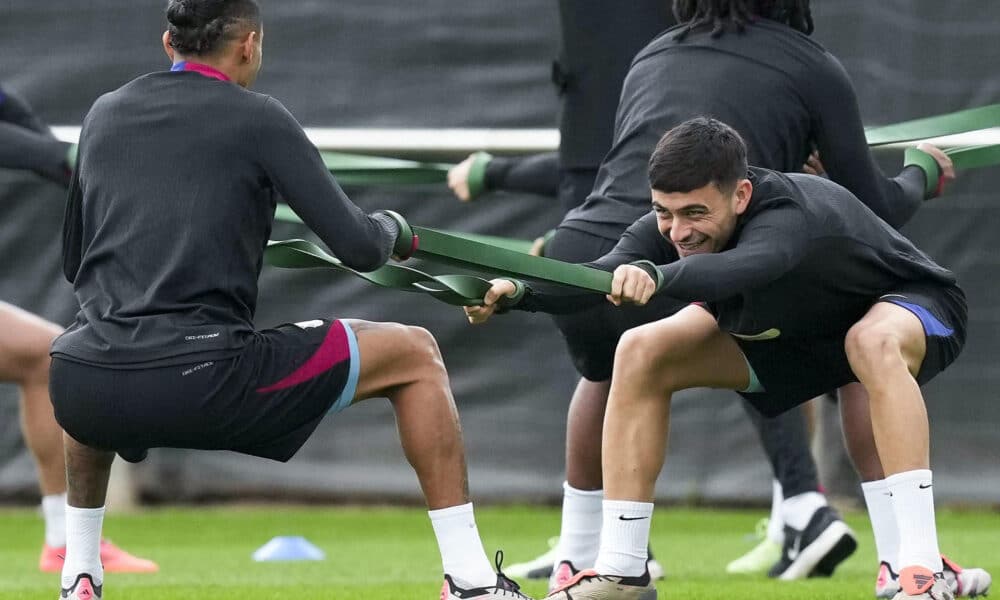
[734, 282, 968, 416]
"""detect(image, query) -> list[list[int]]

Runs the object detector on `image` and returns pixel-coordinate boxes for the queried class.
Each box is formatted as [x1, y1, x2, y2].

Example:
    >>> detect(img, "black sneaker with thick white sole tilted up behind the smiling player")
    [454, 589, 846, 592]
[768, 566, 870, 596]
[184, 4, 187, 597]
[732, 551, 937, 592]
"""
[767, 506, 858, 581]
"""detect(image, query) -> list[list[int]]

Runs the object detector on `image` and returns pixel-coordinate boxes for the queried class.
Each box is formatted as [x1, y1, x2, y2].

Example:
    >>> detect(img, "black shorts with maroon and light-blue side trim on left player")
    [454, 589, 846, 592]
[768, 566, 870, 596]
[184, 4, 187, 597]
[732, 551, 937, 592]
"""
[50, 320, 360, 462]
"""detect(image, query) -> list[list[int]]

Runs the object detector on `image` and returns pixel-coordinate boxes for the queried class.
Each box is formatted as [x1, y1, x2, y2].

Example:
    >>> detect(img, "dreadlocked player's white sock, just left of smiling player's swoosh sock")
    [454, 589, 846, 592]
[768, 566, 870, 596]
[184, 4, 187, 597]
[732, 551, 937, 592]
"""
[554, 482, 604, 571]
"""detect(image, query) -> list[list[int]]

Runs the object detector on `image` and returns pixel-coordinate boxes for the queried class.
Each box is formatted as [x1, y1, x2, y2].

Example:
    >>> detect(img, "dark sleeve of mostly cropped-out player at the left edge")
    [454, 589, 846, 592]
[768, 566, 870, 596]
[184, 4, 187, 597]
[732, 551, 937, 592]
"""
[0, 87, 70, 186]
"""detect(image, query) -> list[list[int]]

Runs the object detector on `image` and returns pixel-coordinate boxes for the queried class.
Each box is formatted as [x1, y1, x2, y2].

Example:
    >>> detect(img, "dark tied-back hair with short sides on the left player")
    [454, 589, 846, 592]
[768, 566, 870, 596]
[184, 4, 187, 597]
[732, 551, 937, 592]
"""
[167, 0, 260, 56]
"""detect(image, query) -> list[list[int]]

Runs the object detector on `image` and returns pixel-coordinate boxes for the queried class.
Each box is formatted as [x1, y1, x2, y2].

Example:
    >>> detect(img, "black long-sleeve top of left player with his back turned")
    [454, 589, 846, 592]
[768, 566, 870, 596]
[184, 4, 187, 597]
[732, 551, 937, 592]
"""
[52, 65, 399, 367]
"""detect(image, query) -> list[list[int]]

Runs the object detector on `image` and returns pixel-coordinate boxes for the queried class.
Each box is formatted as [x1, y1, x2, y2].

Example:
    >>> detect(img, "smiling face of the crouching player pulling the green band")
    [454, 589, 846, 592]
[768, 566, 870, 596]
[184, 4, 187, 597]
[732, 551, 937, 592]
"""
[652, 179, 753, 258]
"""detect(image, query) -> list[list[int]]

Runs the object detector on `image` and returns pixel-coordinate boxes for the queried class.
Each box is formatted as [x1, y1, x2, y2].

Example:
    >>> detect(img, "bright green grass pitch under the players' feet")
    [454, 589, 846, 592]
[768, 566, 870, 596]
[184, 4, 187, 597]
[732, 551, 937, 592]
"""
[0, 506, 1000, 600]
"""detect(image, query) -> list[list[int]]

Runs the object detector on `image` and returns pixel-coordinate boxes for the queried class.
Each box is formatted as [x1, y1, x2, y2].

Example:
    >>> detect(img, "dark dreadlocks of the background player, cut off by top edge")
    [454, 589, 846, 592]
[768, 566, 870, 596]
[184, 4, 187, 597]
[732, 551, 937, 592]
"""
[674, 0, 813, 40]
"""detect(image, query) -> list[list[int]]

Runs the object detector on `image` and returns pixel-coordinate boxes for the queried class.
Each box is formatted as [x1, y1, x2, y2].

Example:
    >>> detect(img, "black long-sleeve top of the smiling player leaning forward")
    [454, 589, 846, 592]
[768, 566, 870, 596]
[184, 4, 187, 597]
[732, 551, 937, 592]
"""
[516, 168, 955, 339]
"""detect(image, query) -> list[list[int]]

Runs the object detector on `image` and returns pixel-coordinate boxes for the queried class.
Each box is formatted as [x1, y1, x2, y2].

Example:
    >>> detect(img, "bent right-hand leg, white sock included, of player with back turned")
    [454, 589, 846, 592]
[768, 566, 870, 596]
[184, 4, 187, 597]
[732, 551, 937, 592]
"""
[345, 320, 518, 600]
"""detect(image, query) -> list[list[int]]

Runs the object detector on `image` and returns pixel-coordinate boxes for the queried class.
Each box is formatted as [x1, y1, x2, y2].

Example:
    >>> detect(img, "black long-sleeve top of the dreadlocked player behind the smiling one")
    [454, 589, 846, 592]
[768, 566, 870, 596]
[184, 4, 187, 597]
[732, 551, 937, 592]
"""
[563, 19, 925, 239]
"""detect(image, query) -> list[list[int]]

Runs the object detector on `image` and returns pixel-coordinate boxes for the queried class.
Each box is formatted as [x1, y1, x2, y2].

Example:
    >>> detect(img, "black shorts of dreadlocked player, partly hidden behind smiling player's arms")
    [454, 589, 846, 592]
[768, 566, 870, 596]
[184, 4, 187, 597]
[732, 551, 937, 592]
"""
[545, 227, 688, 381]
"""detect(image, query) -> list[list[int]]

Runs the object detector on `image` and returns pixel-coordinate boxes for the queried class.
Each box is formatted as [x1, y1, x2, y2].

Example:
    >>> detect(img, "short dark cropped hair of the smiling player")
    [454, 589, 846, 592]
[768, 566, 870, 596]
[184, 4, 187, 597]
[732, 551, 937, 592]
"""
[649, 117, 747, 194]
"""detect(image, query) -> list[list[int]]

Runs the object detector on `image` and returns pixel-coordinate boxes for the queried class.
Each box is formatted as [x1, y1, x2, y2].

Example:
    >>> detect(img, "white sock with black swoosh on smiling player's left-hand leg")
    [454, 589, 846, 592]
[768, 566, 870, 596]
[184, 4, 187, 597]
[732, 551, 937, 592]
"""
[594, 500, 653, 577]
